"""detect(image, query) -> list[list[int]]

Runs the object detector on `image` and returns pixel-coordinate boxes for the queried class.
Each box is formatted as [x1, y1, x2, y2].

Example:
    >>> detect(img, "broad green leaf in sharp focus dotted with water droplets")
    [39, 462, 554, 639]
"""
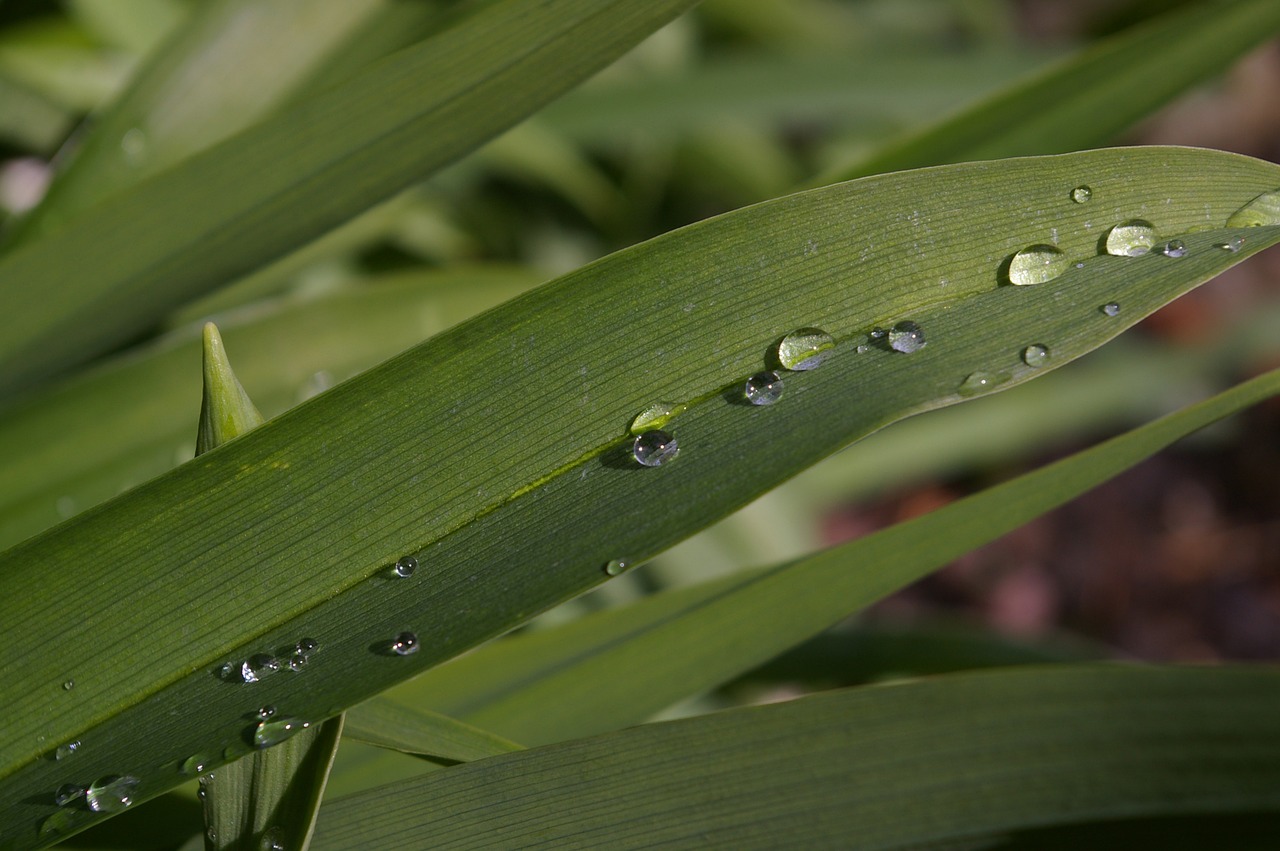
[0, 148, 1280, 841]
